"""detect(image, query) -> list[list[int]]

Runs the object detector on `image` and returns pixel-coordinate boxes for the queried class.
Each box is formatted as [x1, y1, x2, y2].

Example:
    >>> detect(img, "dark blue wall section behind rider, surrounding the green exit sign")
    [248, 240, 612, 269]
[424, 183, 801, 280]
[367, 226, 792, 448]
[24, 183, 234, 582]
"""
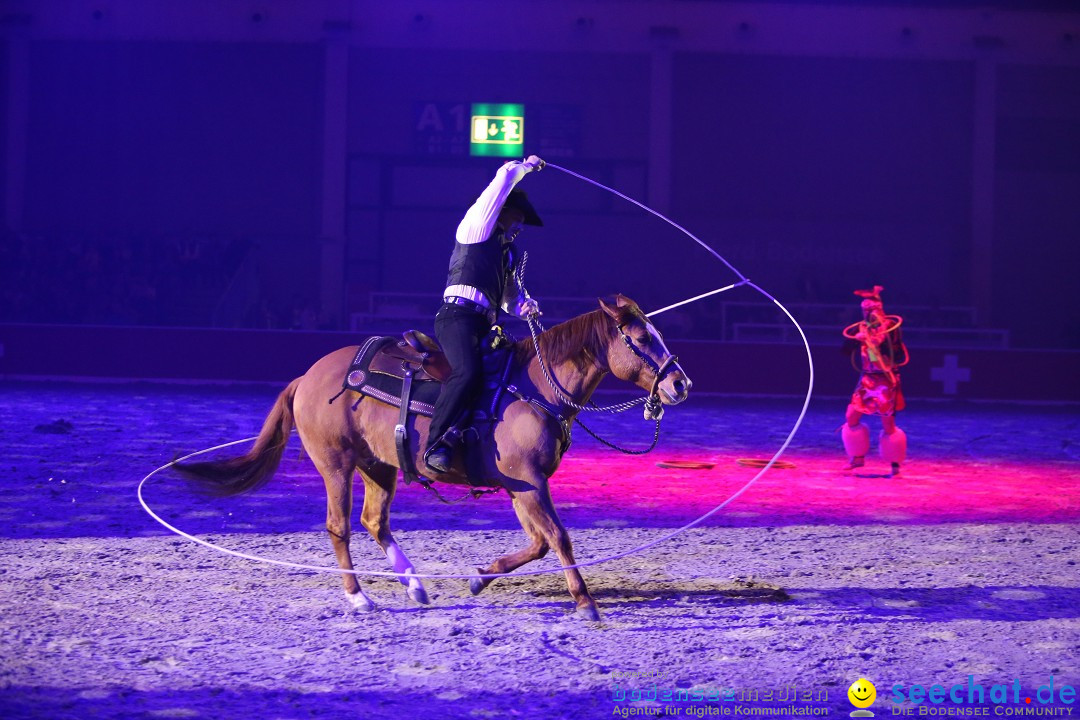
[349, 49, 659, 304]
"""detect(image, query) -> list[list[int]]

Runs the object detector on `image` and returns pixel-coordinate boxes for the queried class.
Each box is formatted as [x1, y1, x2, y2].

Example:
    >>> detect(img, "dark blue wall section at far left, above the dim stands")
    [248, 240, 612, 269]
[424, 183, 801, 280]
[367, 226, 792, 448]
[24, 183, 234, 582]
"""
[24, 41, 322, 235]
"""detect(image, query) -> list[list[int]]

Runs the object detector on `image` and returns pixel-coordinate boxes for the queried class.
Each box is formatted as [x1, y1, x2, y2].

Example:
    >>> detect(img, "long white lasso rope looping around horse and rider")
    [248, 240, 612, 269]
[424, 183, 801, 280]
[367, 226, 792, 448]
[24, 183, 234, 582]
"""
[137, 163, 813, 580]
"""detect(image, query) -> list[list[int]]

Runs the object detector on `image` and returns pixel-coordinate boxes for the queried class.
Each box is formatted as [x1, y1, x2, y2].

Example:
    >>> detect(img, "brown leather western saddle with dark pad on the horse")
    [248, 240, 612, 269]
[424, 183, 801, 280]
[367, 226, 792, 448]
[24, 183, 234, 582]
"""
[339, 330, 513, 486]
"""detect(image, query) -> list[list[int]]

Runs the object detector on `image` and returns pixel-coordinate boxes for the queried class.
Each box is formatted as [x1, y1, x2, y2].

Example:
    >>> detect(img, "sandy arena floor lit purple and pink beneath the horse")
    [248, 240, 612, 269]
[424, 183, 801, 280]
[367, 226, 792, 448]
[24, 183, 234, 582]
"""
[0, 382, 1080, 719]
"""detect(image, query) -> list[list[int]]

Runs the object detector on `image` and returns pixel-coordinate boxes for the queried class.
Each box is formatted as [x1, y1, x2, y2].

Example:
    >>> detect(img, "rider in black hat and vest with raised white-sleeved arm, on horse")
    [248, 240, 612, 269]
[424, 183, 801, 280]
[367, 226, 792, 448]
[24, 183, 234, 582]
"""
[423, 155, 544, 473]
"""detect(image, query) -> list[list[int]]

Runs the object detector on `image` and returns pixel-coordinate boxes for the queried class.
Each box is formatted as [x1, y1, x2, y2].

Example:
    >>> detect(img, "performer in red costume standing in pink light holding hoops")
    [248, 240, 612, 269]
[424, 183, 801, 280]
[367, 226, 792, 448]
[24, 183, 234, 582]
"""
[840, 285, 908, 477]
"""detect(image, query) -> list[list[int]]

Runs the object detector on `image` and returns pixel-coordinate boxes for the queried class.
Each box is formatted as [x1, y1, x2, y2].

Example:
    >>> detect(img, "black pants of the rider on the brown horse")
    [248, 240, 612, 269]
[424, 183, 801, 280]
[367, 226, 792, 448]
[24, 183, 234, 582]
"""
[428, 303, 491, 448]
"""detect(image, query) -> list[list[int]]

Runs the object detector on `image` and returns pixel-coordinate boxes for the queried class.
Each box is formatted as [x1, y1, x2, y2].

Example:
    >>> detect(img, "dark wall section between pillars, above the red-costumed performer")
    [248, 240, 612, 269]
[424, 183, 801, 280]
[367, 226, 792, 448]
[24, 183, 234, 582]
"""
[673, 54, 973, 313]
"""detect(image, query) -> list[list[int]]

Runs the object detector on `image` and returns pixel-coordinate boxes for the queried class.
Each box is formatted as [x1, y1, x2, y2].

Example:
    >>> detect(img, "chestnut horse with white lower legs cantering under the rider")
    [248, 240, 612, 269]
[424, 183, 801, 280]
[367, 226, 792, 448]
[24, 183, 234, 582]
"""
[171, 295, 691, 621]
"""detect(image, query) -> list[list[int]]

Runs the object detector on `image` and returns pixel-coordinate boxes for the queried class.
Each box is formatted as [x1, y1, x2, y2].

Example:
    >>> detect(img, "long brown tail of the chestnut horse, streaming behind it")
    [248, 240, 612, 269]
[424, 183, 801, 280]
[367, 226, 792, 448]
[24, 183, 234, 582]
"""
[174, 378, 300, 495]
